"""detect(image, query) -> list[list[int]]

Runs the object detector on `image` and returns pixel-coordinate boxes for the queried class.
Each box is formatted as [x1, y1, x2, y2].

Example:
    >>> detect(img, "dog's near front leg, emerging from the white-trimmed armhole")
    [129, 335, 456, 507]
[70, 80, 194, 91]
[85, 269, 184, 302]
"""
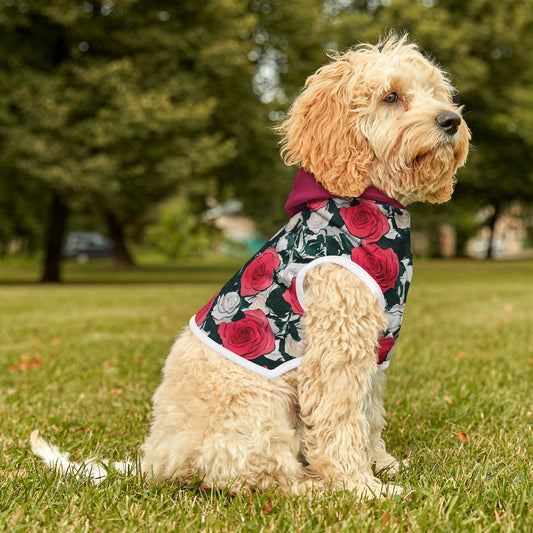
[298, 264, 400, 496]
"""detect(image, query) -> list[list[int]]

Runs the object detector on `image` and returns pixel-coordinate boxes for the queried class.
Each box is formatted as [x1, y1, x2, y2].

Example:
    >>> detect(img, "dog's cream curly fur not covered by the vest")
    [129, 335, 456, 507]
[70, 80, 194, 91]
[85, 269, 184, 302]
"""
[32, 36, 470, 496]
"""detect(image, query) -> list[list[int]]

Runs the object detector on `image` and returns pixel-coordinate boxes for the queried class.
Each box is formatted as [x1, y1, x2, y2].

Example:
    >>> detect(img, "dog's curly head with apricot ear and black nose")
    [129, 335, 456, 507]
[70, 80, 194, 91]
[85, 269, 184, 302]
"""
[279, 36, 470, 204]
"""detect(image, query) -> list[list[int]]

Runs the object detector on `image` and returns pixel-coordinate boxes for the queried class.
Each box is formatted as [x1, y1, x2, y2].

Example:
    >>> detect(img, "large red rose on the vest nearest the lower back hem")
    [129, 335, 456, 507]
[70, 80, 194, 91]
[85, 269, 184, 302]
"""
[218, 309, 276, 359]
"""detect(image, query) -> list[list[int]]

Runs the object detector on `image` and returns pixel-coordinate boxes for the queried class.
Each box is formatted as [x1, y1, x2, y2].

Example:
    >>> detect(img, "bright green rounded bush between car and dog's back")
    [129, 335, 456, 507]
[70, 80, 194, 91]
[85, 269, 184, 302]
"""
[147, 196, 221, 259]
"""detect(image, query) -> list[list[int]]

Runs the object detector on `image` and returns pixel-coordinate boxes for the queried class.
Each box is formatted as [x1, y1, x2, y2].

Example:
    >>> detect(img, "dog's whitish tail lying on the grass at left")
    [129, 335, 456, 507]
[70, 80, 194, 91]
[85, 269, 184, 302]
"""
[30, 429, 137, 485]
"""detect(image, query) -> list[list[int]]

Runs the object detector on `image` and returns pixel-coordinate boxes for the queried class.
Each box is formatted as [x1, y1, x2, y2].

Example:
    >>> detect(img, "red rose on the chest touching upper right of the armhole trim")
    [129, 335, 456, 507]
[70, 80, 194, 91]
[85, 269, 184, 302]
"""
[352, 244, 400, 292]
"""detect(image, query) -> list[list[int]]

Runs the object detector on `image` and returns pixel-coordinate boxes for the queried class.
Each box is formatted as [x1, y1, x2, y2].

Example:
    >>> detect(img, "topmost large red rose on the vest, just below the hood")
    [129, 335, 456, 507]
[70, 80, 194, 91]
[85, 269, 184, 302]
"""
[340, 200, 389, 243]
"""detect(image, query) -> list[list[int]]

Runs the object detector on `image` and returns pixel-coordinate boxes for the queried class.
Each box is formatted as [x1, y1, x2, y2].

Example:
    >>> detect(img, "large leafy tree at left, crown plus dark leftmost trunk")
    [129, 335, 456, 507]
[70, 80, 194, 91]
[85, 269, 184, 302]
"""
[0, 0, 252, 281]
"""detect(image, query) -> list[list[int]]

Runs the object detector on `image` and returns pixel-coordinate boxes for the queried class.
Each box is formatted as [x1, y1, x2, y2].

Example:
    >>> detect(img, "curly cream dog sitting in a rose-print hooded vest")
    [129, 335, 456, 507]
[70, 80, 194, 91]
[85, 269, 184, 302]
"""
[32, 37, 470, 495]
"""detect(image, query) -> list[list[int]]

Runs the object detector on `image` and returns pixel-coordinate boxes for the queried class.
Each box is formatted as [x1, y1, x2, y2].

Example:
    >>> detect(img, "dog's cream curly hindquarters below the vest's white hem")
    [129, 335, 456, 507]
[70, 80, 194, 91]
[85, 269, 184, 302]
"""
[142, 331, 307, 492]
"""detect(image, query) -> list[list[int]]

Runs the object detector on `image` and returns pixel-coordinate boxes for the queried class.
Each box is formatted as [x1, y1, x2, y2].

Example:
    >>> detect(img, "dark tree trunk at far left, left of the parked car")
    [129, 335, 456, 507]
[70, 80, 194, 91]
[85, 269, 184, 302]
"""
[41, 193, 69, 283]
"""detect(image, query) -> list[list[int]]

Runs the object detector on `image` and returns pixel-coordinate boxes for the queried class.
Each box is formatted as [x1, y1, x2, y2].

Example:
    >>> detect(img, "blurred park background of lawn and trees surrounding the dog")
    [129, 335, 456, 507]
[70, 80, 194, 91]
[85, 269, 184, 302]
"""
[0, 0, 533, 532]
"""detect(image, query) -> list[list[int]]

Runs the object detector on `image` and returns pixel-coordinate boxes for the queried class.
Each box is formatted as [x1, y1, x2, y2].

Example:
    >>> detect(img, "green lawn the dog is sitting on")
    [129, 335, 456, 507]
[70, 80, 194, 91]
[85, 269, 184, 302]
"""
[0, 261, 533, 532]
